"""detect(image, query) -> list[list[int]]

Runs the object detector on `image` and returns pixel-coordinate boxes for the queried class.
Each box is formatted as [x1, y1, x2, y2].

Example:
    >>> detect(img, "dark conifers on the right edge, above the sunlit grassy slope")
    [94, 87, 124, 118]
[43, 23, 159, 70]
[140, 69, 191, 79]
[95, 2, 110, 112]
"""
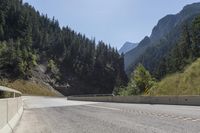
[155, 17, 200, 79]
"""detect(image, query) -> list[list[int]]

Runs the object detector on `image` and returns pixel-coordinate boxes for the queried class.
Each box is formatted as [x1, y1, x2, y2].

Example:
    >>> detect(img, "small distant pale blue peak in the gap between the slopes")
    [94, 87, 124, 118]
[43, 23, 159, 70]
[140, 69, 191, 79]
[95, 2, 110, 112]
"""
[119, 42, 138, 54]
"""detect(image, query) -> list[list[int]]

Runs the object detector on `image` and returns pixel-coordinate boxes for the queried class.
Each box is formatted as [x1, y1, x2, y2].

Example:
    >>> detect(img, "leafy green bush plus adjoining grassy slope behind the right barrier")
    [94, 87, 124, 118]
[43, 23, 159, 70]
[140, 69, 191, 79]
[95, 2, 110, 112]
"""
[113, 58, 200, 96]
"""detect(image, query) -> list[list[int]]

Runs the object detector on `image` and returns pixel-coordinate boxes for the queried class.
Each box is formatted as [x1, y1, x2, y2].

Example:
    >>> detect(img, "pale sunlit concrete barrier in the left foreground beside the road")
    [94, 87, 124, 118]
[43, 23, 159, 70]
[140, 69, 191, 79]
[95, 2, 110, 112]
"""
[0, 97, 23, 133]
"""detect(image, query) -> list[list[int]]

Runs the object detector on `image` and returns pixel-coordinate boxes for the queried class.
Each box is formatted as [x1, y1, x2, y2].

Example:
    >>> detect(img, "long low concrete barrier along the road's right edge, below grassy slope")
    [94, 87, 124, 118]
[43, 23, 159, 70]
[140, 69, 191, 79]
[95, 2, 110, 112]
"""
[67, 96, 200, 106]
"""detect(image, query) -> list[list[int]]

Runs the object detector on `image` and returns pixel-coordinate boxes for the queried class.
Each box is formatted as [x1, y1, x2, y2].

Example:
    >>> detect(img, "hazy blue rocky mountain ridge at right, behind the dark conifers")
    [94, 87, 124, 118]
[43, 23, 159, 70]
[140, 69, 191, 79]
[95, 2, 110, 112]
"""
[124, 3, 200, 74]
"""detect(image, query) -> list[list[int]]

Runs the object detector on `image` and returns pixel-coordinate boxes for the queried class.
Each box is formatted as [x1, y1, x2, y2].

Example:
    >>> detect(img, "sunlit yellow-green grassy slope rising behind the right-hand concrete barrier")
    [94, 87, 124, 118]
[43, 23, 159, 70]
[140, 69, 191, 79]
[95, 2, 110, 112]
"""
[148, 58, 200, 95]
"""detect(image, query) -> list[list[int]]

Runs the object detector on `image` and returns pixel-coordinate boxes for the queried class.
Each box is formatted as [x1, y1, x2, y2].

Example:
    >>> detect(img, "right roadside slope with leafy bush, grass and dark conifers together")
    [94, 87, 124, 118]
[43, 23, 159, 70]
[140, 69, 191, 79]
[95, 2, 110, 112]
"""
[113, 17, 200, 96]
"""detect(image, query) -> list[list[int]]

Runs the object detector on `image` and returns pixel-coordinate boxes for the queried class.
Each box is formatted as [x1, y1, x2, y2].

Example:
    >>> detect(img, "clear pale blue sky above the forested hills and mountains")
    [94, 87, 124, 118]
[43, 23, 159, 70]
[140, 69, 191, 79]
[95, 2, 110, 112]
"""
[24, 0, 200, 48]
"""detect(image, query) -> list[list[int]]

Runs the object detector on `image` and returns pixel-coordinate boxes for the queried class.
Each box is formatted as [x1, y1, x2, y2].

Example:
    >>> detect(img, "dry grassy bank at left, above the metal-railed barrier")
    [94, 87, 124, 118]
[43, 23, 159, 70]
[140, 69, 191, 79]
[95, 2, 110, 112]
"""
[0, 80, 56, 96]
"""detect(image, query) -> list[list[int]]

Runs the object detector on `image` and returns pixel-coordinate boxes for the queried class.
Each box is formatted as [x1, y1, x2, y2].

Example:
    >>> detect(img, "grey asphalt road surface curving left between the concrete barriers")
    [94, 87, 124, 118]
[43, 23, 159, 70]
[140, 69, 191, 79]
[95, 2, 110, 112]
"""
[14, 97, 200, 133]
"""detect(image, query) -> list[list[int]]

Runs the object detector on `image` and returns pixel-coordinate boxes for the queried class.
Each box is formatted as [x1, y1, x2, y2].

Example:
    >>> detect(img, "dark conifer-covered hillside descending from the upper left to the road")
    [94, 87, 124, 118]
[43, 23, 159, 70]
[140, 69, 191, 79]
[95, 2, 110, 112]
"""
[0, 0, 127, 95]
